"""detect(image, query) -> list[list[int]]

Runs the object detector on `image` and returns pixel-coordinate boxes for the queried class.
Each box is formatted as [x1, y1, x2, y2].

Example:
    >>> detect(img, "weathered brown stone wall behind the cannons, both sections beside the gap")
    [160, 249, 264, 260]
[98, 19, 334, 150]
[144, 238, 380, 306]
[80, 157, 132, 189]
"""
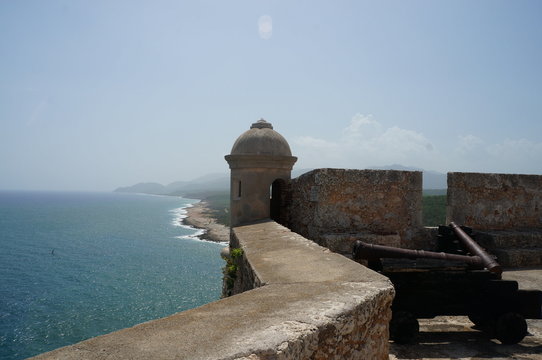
[284, 169, 542, 267]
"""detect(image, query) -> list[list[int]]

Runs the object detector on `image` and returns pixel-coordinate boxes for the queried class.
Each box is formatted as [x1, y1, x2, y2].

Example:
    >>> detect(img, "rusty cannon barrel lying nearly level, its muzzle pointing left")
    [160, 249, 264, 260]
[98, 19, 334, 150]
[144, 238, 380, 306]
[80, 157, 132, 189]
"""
[352, 240, 484, 269]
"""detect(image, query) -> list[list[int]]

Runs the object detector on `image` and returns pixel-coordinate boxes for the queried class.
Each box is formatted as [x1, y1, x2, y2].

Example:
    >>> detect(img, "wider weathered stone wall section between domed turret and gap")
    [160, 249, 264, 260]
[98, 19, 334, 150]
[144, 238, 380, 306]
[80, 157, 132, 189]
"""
[289, 169, 422, 247]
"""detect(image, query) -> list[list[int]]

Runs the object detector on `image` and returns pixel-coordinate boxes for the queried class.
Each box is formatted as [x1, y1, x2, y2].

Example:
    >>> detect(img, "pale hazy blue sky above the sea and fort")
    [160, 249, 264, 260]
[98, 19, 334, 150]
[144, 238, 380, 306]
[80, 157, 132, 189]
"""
[0, 0, 542, 190]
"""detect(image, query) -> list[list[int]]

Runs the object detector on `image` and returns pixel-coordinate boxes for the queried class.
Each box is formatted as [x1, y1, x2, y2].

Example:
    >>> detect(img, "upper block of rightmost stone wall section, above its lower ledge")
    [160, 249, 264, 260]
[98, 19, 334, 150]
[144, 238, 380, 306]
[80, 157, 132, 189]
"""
[446, 173, 542, 230]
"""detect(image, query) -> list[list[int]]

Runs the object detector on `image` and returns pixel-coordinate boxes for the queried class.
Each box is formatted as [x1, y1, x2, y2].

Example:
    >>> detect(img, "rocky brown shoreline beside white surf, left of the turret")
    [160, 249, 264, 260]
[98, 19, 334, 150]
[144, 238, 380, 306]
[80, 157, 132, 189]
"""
[181, 200, 230, 243]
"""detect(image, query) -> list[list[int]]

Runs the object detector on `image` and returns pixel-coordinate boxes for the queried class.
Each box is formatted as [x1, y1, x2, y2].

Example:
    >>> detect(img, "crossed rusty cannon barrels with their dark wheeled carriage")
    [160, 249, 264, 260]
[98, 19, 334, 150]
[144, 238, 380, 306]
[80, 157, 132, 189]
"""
[353, 223, 542, 344]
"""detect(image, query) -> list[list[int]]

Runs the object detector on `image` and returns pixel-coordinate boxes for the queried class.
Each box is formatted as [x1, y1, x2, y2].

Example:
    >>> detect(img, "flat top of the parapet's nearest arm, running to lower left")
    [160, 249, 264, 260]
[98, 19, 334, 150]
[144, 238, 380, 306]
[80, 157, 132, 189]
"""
[35, 283, 389, 360]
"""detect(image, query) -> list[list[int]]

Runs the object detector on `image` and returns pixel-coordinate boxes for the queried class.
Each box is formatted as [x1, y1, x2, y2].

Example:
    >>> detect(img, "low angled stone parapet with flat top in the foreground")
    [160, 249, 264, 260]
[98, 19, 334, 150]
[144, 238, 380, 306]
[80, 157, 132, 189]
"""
[36, 221, 394, 360]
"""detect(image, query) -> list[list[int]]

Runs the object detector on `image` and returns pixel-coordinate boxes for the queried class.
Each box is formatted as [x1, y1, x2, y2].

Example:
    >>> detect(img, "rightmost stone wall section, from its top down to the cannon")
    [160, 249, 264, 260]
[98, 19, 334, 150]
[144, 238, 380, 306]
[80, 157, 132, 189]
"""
[446, 173, 542, 267]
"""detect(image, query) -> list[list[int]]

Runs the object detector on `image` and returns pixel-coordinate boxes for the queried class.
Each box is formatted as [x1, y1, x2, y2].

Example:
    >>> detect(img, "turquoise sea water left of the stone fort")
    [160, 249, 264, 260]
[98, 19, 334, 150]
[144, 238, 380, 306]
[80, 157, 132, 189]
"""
[0, 192, 223, 359]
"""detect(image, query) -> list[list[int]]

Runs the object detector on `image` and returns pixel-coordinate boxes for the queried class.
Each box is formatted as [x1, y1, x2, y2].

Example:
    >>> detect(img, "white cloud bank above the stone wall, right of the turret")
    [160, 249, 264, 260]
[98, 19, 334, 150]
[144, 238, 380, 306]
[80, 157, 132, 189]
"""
[292, 114, 542, 174]
